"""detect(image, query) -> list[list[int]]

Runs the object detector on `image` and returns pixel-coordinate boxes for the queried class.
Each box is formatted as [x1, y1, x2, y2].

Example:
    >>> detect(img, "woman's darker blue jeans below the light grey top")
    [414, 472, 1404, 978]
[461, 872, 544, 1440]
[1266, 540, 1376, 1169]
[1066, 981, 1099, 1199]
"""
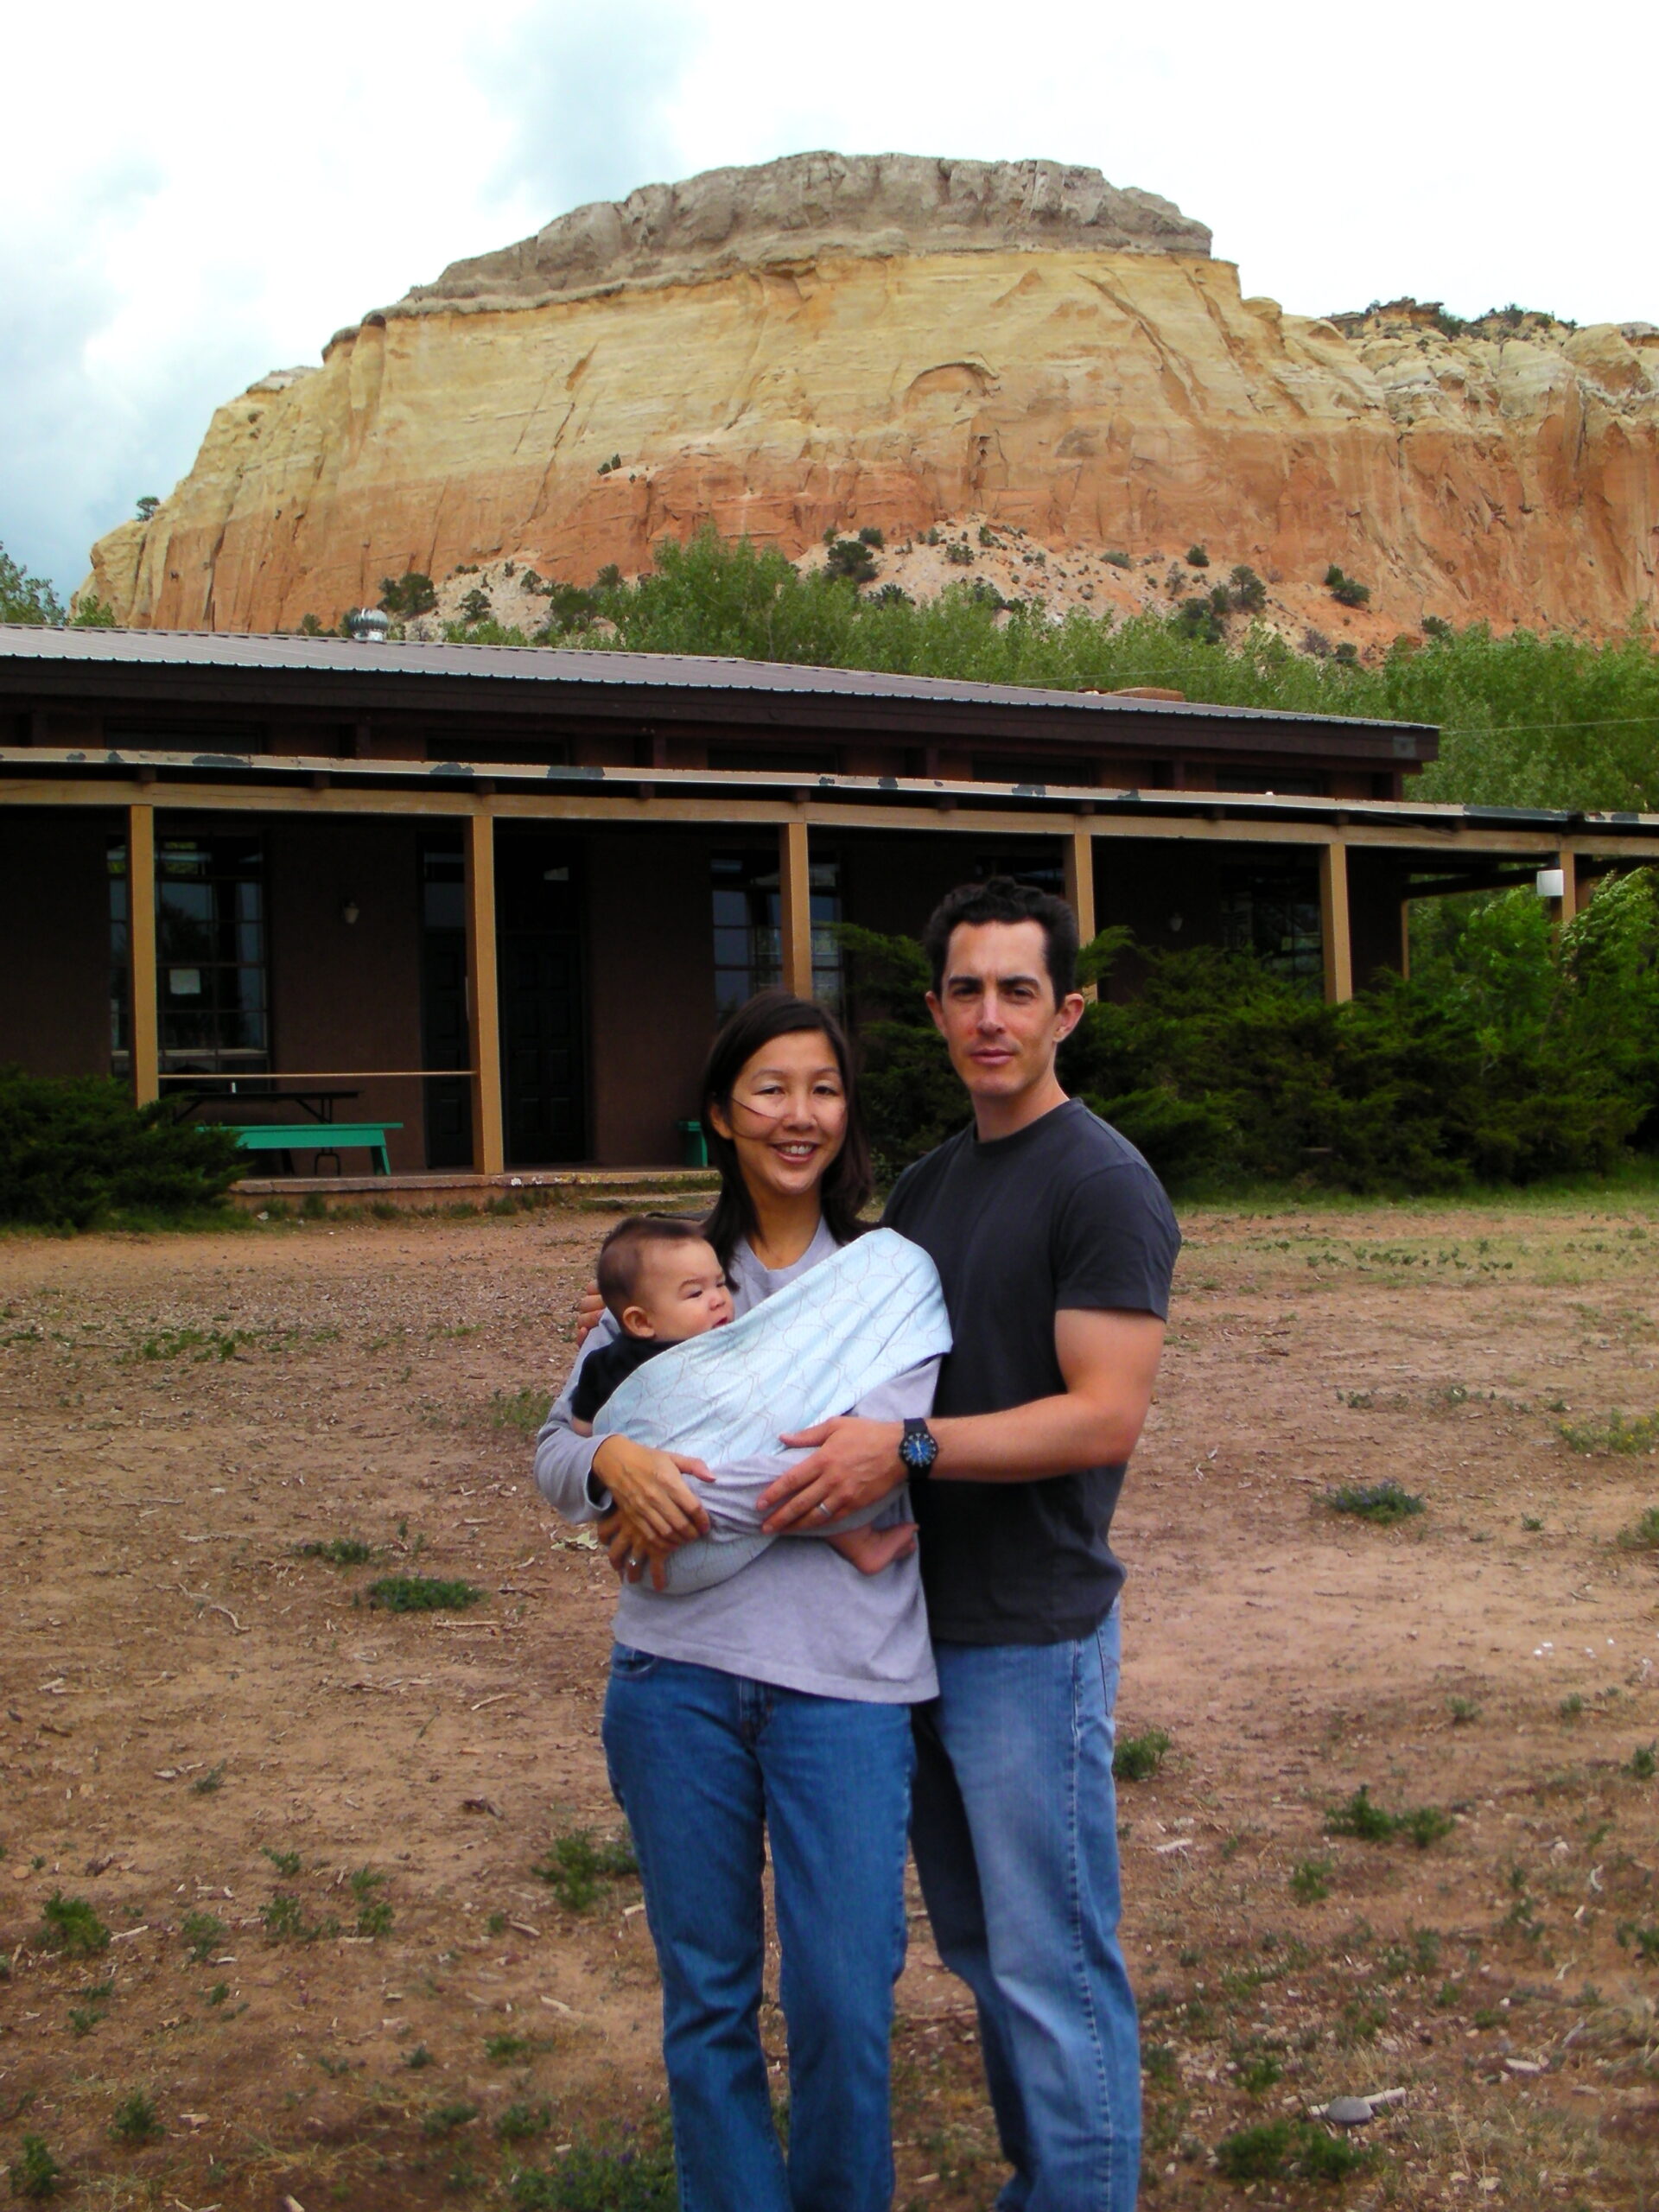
[604, 1643, 913, 2212]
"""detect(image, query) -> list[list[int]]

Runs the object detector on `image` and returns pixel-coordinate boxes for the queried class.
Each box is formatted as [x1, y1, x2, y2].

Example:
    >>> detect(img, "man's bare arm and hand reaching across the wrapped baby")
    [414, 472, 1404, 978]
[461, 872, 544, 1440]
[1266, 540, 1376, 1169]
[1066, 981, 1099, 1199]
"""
[761, 1307, 1164, 1533]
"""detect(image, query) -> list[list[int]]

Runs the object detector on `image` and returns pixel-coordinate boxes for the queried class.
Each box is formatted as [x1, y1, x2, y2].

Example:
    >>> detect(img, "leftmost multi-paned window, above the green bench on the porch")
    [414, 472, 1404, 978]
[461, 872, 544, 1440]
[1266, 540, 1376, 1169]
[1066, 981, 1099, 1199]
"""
[108, 836, 270, 1075]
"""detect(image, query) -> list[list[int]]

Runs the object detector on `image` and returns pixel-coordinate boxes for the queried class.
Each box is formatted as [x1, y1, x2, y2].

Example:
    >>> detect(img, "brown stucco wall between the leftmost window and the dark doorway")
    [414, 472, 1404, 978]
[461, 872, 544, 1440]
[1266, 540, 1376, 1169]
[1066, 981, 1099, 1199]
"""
[265, 818, 427, 1174]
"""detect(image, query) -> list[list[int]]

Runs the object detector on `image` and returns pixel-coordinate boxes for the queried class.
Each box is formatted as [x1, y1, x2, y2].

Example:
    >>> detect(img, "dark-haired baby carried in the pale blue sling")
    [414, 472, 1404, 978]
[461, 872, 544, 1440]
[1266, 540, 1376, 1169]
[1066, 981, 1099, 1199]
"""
[570, 1214, 916, 1575]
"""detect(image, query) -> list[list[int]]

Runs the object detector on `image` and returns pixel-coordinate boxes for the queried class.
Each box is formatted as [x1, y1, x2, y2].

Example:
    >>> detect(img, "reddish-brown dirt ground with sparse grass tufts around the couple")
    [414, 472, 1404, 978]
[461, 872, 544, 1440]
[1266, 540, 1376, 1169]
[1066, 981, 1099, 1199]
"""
[0, 1199, 1659, 2212]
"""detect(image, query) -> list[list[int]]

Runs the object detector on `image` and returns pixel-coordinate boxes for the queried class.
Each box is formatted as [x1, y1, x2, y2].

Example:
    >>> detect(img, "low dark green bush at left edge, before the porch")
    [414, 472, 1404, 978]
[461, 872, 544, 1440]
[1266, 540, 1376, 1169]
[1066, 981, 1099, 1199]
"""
[0, 1068, 248, 1228]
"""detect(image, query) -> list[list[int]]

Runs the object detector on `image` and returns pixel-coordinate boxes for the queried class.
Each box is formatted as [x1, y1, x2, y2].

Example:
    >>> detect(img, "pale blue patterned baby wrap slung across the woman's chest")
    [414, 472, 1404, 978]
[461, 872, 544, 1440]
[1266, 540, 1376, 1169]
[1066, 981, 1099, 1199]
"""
[593, 1230, 951, 1592]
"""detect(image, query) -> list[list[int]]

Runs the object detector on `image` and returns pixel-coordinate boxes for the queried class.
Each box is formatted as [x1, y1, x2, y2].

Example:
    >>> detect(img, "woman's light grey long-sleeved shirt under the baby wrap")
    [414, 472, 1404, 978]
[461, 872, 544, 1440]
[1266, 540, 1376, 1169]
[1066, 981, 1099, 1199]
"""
[536, 1224, 938, 1706]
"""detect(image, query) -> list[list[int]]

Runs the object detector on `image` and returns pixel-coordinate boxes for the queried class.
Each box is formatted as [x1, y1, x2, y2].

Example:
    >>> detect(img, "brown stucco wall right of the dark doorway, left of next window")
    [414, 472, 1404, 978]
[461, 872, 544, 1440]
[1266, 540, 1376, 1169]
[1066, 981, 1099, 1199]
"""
[584, 827, 715, 1168]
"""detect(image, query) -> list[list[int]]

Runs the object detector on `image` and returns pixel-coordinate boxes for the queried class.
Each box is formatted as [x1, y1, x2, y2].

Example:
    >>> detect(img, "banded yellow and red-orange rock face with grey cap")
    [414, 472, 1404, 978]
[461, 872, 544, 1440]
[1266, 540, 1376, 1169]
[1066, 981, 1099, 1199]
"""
[84, 155, 1659, 644]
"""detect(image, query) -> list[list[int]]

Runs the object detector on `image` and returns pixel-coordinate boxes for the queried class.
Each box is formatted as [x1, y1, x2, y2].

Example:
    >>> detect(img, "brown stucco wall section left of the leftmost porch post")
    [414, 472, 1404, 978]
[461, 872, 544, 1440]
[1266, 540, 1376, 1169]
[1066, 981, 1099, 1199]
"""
[0, 810, 124, 1075]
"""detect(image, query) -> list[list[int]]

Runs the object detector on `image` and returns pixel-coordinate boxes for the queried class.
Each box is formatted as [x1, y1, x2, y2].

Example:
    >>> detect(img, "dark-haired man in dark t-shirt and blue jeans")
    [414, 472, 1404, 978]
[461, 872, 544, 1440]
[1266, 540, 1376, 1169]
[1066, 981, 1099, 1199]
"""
[763, 878, 1181, 2212]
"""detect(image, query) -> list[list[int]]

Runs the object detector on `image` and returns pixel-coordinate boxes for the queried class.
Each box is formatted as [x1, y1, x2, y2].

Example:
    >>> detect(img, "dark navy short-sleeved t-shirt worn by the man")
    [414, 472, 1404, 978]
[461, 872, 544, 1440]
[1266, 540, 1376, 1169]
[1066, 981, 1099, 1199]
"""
[882, 1099, 1181, 1643]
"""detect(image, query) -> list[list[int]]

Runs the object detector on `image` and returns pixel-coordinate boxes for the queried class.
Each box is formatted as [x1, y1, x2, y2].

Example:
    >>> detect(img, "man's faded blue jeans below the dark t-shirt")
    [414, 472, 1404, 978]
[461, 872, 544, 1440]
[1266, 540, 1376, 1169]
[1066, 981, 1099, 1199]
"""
[912, 1606, 1141, 2212]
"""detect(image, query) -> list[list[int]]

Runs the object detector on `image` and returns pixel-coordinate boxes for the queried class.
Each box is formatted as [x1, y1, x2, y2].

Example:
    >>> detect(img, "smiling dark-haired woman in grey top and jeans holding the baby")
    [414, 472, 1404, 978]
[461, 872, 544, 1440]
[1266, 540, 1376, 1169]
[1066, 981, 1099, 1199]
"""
[536, 991, 938, 2212]
